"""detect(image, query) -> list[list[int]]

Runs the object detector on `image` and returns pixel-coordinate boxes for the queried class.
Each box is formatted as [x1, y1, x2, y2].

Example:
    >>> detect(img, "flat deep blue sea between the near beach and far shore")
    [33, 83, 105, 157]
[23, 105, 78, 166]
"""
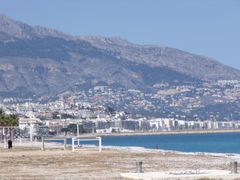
[64, 132, 240, 153]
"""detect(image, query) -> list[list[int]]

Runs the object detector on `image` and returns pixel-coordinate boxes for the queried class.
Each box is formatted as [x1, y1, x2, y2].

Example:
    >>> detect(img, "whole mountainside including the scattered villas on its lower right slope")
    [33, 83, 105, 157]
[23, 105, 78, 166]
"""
[0, 15, 240, 119]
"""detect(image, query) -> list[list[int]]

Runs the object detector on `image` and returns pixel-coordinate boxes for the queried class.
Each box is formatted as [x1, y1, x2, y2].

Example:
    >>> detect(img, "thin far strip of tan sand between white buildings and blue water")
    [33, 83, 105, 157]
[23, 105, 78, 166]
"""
[97, 129, 240, 137]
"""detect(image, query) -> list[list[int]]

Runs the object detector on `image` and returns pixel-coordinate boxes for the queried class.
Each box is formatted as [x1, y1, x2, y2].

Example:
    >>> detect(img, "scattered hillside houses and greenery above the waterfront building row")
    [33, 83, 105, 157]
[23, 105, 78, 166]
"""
[0, 80, 240, 117]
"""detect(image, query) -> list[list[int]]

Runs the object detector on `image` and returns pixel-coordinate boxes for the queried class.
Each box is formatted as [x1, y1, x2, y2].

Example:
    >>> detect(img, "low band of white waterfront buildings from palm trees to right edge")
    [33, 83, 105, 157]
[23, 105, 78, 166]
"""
[14, 114, 240, 136]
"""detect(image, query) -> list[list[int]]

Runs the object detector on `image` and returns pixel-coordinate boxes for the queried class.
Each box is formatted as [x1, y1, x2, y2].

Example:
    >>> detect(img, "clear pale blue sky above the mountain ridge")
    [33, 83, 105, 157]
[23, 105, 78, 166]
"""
[0, 0, 240, 69]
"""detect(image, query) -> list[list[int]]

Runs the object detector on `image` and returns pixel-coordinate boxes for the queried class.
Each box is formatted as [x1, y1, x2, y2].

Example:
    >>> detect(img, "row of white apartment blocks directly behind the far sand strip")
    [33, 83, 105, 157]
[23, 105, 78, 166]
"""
[96, 118, 240, 133]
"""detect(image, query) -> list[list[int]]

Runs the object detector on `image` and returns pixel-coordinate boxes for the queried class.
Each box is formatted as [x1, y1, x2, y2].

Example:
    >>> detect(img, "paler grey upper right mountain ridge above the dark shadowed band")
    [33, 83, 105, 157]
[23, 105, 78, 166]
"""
[83, 36, 240, 81]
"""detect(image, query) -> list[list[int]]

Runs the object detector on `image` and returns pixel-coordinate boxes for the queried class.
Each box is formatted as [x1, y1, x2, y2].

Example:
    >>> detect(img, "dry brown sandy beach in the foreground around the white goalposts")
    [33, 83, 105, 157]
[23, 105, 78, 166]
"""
[0, 143, 238, 179]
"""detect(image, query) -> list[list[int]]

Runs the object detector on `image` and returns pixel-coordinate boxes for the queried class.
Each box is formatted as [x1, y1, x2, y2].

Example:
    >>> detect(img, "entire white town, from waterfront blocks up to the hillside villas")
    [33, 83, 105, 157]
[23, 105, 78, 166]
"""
[1, 81, 240, 137]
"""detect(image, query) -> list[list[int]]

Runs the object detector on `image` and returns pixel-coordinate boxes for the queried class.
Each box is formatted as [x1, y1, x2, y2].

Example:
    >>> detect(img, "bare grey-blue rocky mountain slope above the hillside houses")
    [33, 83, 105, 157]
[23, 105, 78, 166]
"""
[0, 15, 240, 97]
